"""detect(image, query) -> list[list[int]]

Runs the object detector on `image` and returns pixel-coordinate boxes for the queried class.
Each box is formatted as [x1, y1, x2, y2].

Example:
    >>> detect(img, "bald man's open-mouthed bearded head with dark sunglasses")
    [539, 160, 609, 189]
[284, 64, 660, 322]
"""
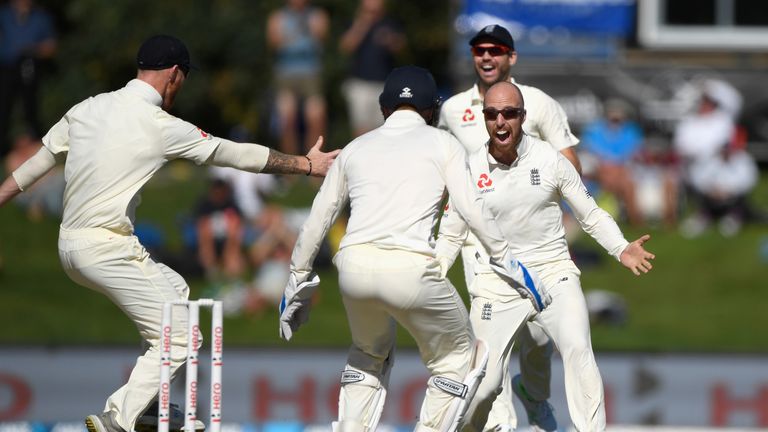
[483, 82, 525, 165]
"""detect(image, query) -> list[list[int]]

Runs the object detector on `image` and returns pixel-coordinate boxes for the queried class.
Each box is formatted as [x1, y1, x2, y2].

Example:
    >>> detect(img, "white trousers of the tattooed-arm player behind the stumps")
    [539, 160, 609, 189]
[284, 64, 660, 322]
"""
[59, 228, 192, 431]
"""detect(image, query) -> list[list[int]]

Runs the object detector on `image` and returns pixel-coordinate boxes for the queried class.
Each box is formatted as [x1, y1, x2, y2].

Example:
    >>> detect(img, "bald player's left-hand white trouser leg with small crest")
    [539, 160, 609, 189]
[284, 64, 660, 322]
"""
[463, 273, 536, 431]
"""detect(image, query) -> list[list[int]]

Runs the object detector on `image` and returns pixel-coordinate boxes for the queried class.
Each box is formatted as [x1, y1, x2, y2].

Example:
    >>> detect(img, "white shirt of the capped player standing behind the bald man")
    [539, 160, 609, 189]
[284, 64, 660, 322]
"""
[439, 78, 579, 152]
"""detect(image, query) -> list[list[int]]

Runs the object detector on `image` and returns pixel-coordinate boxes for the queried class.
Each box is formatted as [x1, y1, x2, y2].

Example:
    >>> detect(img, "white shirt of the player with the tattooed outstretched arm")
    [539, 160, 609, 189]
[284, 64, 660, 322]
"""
[43, 79, 220, 233]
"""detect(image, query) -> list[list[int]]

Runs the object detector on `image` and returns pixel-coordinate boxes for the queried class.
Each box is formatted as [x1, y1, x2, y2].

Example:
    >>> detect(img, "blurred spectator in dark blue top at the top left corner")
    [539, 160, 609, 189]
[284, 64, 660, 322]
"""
[0, 0, 56, 157]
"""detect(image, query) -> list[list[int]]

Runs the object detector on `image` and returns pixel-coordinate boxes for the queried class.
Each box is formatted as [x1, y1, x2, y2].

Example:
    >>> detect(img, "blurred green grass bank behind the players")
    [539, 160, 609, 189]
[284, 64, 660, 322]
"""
[0, 162, 768, 353]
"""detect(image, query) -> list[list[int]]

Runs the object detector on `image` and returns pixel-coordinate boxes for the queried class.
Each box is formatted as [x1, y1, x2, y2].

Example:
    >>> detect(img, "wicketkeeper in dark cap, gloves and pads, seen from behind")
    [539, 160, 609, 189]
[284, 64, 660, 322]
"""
[280, 66, 549, 432]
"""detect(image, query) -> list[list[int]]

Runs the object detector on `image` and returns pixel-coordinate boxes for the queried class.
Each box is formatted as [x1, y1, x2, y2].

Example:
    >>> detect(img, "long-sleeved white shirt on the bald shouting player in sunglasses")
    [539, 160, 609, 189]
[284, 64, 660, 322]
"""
[437, 135, 629, 273]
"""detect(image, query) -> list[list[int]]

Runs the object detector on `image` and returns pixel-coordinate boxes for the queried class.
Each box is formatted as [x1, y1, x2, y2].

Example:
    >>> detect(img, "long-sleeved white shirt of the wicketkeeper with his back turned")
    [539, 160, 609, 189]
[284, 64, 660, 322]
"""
[291, 110, 520, 281]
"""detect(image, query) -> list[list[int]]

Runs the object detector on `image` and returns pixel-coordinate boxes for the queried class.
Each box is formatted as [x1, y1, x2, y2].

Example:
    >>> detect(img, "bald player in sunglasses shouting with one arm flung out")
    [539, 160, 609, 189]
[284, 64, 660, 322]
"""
[436, 82, 655, 431]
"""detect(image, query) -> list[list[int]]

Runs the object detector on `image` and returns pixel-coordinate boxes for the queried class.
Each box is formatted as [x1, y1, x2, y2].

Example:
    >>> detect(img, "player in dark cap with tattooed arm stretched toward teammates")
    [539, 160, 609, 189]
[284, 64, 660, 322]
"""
[0, 35, 337, 432]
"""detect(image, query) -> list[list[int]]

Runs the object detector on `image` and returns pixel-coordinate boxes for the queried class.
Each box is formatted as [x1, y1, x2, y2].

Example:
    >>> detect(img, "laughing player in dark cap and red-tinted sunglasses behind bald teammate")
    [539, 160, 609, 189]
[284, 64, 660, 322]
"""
[439, 25, 581, 431]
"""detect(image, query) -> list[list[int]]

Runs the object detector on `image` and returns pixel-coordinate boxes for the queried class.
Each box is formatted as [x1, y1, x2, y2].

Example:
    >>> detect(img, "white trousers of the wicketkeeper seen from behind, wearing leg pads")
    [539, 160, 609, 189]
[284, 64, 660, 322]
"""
[334, 245, 475, 430]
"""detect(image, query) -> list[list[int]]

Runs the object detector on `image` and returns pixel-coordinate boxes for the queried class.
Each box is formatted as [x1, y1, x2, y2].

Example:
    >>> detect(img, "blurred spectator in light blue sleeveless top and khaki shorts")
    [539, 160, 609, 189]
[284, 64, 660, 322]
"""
[267, 0, 329, 154]
